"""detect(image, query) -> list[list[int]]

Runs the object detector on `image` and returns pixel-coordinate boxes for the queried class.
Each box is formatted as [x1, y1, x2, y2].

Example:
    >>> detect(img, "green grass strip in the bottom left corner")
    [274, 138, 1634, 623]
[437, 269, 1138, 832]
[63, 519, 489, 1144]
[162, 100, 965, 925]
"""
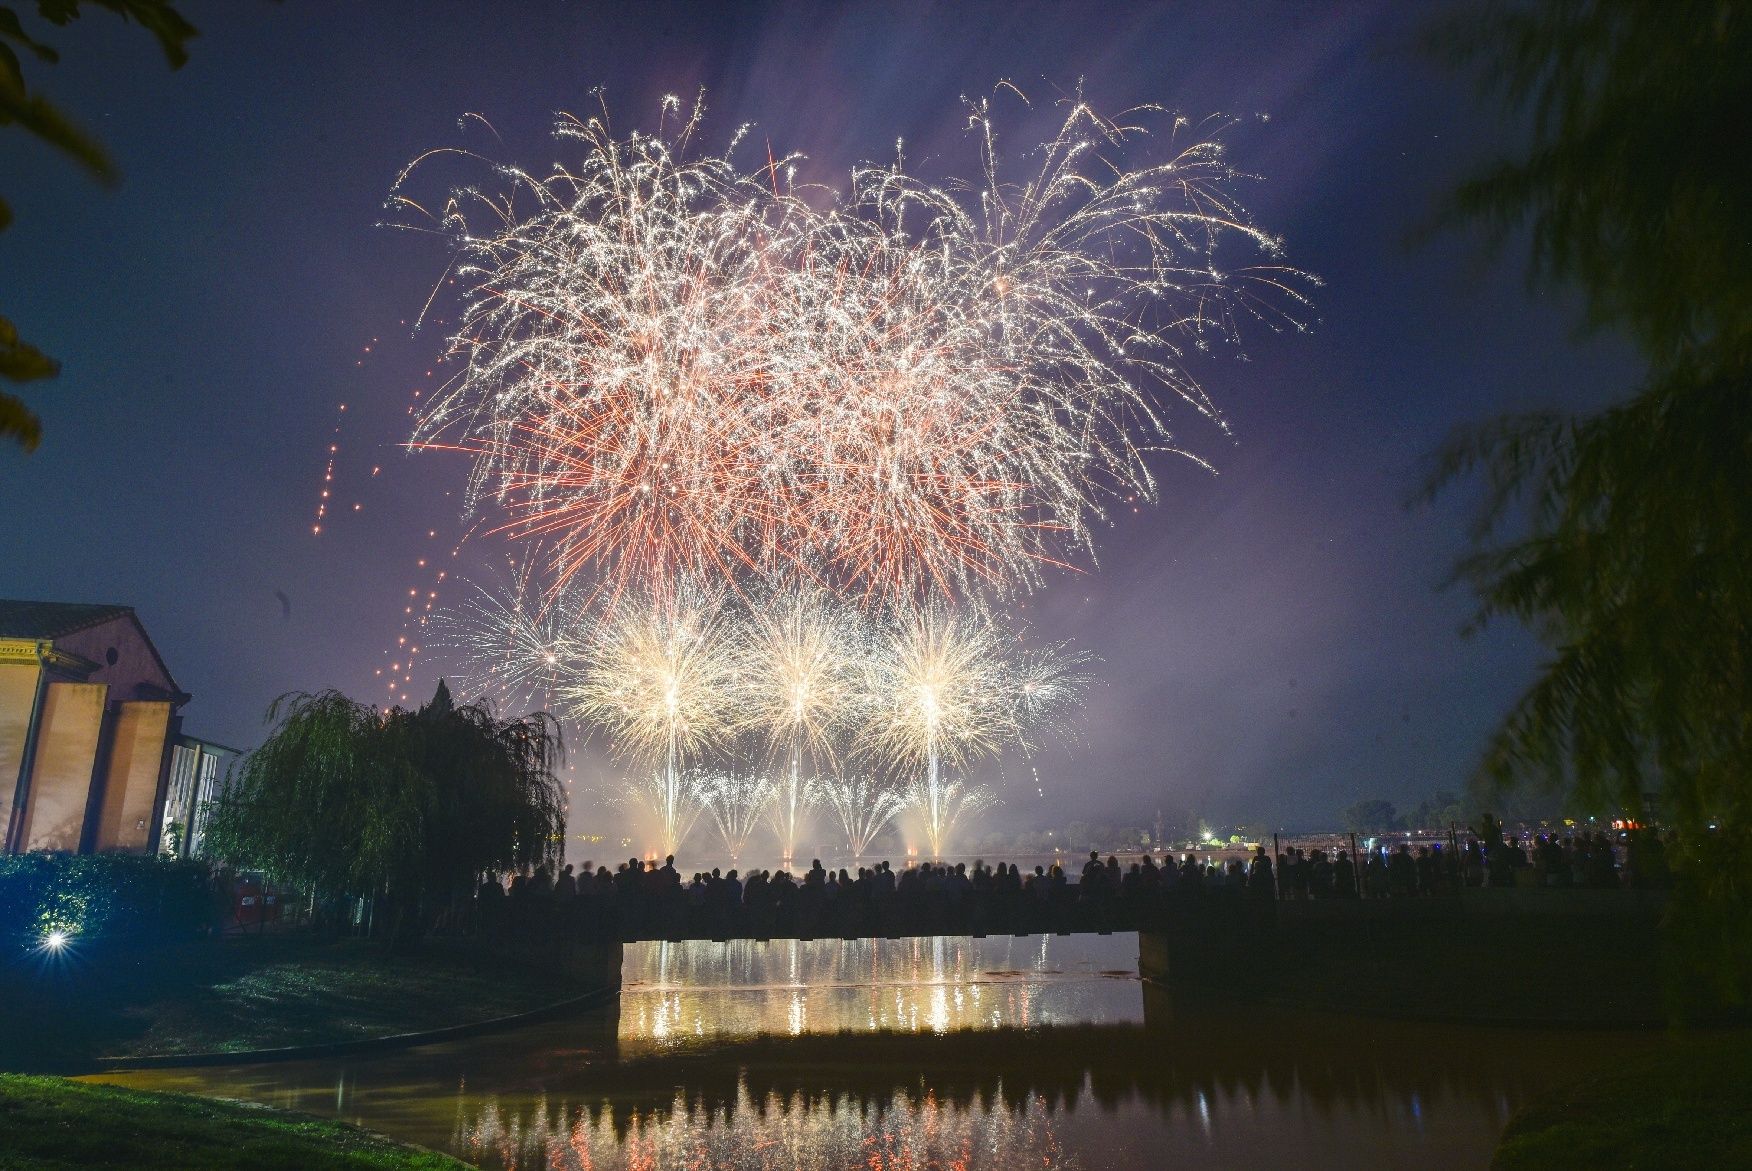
[0, 1075, 468, 1171]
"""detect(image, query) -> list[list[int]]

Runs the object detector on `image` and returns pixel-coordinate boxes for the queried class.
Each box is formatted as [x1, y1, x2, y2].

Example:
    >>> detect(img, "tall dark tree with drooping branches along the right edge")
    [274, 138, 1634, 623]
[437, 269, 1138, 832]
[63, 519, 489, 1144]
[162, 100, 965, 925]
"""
[1424, 0, 1752, 999]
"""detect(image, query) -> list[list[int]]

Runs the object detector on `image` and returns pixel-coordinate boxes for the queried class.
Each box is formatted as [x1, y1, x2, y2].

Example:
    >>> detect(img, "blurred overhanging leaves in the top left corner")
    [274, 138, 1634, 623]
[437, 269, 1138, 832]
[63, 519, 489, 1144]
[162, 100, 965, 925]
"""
[0, 0, 194, 451]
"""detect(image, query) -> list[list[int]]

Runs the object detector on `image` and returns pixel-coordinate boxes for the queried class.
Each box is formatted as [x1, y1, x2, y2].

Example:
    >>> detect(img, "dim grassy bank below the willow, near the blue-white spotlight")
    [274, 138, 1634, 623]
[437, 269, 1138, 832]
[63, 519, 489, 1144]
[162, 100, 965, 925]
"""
[0, 936, 578, 1071]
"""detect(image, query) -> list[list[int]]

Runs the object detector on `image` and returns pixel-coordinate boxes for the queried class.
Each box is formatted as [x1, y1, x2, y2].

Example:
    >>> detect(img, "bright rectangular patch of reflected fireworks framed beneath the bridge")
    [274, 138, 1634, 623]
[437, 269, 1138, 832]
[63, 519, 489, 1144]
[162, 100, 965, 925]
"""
[620, 934, 1144, 1052]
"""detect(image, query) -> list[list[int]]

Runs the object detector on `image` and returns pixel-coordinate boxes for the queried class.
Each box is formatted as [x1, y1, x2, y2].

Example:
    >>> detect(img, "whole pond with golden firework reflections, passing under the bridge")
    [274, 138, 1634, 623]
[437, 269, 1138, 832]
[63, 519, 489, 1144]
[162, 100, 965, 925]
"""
[95, 934, 1652, 1171]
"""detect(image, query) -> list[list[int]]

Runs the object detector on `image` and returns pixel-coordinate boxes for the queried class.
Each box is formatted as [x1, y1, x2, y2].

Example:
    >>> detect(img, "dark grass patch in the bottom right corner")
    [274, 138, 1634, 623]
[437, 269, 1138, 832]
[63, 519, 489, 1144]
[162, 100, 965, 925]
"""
[1491, 1033, 1752, 1171]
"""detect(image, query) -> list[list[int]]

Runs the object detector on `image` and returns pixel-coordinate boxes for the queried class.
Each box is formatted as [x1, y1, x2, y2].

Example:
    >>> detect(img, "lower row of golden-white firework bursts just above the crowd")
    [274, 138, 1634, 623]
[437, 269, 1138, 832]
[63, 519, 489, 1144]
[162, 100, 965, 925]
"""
[443, 587, 1088, 857]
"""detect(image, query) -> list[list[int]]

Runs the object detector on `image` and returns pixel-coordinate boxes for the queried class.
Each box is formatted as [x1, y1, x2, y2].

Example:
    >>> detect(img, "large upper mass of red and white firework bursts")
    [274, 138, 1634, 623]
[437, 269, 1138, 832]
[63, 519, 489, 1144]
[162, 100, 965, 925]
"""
[392, 89, 1307, 600]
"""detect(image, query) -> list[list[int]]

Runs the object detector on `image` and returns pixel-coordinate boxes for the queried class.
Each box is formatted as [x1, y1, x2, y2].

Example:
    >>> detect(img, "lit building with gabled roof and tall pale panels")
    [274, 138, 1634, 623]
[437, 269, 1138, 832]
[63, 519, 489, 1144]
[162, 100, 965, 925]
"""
[0, 600, 235, 854]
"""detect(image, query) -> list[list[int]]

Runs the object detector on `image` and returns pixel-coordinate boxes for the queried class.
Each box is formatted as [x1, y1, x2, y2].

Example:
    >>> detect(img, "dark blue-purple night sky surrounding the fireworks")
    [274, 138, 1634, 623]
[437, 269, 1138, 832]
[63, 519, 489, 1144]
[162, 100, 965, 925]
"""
[0, 0, 1636, 829]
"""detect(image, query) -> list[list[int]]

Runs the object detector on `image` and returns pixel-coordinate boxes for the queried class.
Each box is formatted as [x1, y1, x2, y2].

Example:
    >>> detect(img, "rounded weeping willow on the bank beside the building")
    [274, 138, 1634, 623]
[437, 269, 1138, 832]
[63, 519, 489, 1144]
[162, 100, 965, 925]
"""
[207, 682, 566, 939]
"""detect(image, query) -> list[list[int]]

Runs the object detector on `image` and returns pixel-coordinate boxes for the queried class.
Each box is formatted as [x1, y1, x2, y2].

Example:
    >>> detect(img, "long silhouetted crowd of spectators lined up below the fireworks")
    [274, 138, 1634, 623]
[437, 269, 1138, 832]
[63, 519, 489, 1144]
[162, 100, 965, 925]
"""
[473, 817, 1670, 940]
